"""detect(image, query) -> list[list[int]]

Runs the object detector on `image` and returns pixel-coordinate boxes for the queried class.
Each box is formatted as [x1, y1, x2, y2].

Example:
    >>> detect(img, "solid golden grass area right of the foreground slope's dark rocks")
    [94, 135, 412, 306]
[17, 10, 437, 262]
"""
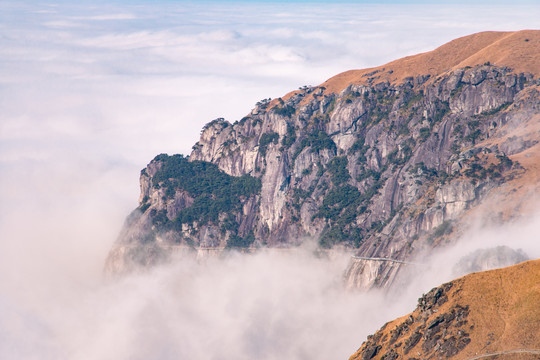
[456, 260, 540, 359]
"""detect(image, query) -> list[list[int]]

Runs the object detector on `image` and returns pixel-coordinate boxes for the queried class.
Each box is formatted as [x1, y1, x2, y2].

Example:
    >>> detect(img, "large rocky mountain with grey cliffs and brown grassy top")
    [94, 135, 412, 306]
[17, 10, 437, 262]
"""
[106, 30, 540, 288]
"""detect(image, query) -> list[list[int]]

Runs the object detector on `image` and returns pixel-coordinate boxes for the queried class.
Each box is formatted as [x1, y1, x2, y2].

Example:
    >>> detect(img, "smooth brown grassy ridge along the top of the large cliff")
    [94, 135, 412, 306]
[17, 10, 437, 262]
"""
[285, 30, 540, 98]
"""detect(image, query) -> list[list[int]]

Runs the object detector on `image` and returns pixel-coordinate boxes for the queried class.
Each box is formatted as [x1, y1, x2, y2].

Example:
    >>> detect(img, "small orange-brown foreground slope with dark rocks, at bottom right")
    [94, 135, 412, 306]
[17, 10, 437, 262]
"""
[350, 260, 540, 360]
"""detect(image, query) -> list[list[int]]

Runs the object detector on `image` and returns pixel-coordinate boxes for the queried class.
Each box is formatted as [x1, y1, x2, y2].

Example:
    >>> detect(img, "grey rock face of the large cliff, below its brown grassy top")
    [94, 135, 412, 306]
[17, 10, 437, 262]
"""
[108, 65, 538, 288]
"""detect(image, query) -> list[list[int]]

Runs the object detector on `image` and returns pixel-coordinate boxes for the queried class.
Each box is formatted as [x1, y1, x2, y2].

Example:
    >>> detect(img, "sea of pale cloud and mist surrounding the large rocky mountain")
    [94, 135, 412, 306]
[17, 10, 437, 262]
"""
[0, 1, 538, 359]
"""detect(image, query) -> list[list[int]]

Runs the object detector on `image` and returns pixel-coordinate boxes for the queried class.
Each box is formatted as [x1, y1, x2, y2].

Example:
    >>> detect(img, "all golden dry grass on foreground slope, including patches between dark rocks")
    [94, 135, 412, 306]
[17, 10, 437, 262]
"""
[350, 260, 540, 360]
